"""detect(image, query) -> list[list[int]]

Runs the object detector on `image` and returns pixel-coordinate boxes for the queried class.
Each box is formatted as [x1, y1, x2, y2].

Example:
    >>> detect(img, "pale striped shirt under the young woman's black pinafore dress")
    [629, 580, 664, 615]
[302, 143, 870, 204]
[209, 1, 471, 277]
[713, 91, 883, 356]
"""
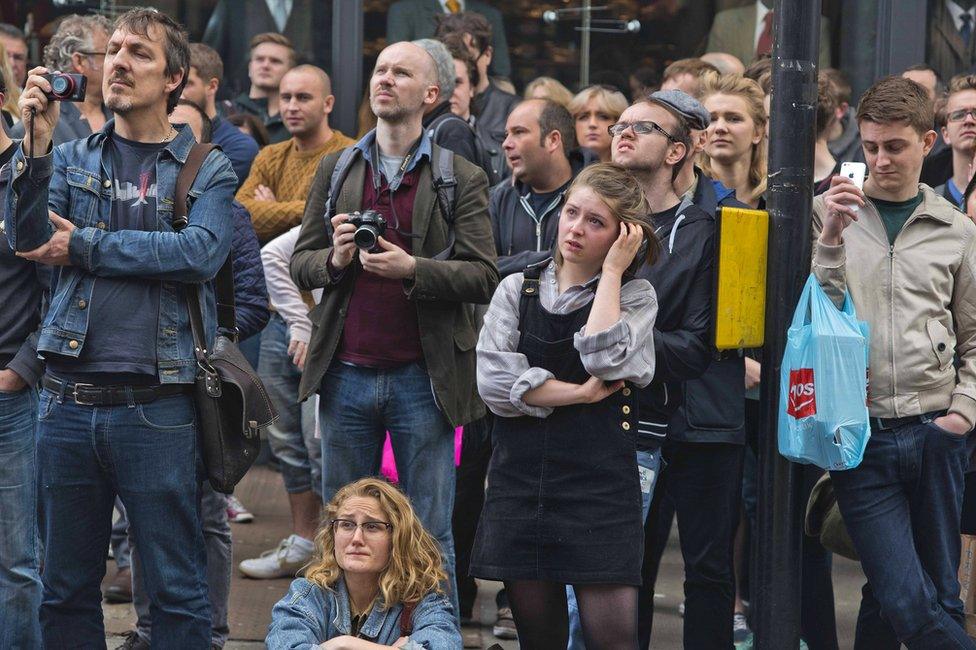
[478, 262, 657, 418]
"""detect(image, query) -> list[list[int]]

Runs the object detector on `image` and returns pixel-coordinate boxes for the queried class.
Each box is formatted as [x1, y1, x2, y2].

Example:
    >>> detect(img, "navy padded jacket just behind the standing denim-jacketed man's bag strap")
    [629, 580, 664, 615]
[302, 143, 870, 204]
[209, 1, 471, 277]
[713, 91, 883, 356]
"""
[231, 201, 271, 341]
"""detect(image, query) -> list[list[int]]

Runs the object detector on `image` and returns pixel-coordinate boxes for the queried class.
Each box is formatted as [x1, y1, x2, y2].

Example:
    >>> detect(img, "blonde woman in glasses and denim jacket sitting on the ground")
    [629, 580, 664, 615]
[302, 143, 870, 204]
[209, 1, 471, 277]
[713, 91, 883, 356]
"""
[265, 478, 462, 650]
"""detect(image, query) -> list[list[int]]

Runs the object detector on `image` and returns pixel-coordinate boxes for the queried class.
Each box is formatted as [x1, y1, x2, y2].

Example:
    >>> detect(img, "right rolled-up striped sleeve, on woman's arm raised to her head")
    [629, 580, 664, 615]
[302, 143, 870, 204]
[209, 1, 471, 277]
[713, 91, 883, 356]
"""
[573, 279, 657, 388]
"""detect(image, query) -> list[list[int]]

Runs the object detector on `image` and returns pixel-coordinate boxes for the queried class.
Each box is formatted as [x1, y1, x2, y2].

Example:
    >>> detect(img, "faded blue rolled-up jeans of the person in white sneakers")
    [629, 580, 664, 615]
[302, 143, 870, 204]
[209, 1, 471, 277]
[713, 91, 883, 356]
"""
[258, 313, 322, 494]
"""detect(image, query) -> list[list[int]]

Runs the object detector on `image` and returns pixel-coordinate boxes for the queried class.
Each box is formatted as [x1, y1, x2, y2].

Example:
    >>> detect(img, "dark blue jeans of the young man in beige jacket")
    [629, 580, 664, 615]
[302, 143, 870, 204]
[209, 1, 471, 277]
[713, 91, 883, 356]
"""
[830, 422, 976, 650]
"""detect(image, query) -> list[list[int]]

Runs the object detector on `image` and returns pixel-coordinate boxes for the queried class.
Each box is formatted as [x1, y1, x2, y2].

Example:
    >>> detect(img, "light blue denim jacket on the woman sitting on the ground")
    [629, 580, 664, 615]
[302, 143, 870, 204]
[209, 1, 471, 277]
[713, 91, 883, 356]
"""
[264, 578, 462, 650]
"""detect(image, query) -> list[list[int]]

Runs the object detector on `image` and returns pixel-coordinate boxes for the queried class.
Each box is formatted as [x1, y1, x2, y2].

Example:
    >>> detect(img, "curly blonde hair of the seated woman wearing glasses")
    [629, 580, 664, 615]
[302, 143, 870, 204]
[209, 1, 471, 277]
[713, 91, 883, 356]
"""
[305, 477, 447, 609]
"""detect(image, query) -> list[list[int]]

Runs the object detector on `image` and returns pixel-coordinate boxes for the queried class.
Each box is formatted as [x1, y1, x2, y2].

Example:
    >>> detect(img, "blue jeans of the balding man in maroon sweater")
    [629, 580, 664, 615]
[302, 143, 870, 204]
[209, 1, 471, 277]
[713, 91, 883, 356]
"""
[319, 363, 458, 616]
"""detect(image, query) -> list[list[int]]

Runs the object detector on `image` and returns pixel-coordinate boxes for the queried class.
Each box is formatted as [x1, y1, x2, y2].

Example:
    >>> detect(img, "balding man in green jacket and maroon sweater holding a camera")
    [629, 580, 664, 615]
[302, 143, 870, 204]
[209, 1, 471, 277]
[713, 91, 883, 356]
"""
[291, 43, 498, 603]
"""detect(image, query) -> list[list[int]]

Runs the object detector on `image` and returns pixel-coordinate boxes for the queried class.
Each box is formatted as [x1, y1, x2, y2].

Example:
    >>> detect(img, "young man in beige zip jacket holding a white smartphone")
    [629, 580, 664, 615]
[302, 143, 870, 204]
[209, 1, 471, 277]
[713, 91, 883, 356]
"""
[813, 77, 976, 649]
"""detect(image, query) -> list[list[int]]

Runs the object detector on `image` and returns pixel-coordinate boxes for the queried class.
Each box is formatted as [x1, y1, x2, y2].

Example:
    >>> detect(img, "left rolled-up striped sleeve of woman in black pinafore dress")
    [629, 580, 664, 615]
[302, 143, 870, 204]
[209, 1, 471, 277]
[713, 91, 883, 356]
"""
[478, 273, 553, 418]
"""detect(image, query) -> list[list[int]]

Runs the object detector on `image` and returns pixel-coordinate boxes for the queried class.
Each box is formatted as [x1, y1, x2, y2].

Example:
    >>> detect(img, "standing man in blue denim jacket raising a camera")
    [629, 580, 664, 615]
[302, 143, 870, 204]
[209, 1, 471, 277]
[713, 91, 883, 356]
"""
[6, 10, 237, 649]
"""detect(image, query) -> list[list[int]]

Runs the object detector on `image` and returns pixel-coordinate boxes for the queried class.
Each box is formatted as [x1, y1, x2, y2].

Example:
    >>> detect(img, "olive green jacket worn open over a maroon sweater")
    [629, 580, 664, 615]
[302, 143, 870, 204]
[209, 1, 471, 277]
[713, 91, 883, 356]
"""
[291, 145, 498, 426]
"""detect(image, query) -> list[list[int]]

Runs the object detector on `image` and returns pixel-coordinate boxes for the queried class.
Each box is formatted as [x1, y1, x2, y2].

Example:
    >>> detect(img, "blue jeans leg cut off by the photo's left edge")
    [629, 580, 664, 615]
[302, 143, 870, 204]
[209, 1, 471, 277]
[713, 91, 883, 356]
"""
[0, 388, 41, 648]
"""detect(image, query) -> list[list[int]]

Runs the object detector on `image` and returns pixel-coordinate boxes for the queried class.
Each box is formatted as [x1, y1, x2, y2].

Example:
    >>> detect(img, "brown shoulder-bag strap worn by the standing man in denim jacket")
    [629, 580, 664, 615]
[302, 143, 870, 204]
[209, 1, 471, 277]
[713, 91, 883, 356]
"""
[173, 144, 237, 354]
